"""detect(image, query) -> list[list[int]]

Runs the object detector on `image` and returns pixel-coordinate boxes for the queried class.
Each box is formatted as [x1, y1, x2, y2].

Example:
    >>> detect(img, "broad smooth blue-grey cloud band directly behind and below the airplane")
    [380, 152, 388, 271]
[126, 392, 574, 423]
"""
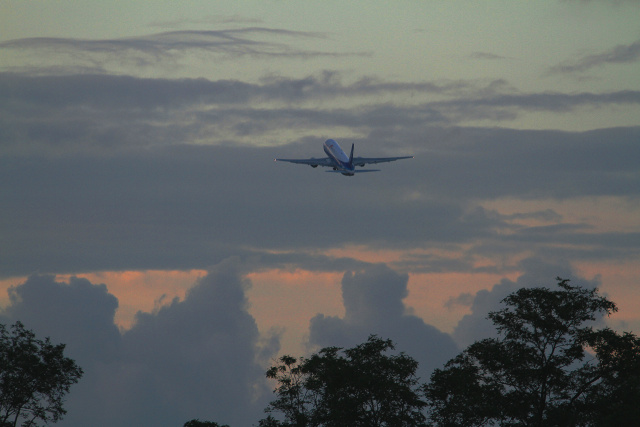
[0, 120, 640, 276]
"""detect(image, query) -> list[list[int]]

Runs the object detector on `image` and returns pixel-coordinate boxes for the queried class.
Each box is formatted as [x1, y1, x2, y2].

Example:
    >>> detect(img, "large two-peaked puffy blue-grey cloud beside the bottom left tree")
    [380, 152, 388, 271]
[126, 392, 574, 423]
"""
[1, 259, 279, 426]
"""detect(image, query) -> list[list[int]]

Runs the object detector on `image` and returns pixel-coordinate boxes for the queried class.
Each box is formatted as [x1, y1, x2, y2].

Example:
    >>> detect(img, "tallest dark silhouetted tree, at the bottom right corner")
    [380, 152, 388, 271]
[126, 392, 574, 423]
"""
[425, 278, 640, 426]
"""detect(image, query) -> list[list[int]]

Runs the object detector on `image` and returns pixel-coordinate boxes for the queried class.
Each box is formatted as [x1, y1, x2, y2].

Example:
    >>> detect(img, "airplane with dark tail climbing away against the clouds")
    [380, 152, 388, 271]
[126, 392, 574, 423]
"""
[274, 139, 413, 176]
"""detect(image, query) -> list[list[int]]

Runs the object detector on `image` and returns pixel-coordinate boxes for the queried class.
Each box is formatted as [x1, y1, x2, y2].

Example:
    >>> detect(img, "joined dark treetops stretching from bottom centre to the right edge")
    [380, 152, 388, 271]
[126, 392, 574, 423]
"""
[255, 278, 640, 427]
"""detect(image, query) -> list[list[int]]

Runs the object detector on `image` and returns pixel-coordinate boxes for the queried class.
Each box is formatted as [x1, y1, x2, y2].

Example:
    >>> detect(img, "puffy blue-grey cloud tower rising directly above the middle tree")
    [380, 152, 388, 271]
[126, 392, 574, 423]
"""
[309, 264, 457, 379]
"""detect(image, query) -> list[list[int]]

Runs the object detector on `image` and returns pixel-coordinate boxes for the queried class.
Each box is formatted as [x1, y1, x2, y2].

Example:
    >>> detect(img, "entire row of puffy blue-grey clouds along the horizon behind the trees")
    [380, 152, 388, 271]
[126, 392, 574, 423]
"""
[0, 258, 620, 426]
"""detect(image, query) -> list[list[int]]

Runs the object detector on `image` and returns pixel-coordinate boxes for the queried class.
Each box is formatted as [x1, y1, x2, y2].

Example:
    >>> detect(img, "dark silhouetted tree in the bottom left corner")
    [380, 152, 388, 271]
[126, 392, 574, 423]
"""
[0, 322, 83, 427]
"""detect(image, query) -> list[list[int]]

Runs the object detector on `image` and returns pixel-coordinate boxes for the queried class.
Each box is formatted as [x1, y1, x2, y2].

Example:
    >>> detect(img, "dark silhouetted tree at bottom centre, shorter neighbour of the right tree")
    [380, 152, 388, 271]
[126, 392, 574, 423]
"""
[260, 335, 426, 427]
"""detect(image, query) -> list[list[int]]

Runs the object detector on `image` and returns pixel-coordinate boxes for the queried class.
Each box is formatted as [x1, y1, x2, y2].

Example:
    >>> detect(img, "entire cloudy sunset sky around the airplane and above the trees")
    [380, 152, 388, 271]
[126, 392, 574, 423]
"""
[0, 0, 640, 427]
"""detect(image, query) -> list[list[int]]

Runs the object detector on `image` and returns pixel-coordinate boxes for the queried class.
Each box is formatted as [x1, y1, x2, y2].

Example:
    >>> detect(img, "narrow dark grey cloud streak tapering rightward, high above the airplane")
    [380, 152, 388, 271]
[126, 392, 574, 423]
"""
[0, 70, 490, 114]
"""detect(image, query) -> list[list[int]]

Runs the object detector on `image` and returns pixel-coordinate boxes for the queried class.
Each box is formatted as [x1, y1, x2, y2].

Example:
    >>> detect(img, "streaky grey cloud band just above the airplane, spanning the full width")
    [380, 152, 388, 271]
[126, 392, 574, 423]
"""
[0, 71, 640, 161]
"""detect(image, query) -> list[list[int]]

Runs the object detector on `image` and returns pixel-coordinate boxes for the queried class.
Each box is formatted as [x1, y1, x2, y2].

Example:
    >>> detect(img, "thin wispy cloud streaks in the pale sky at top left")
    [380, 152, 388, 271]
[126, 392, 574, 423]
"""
[0, 29, 368, 72]
